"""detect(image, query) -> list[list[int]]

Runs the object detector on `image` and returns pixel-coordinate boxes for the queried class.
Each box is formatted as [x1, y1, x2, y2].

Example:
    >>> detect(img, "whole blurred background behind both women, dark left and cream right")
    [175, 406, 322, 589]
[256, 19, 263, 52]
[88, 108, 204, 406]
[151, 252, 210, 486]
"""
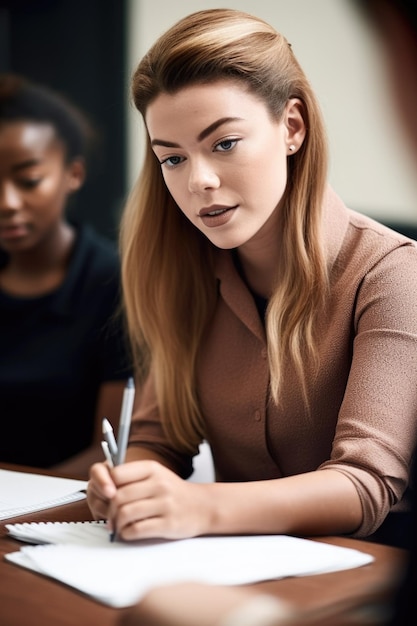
[0, 0, 417, 239]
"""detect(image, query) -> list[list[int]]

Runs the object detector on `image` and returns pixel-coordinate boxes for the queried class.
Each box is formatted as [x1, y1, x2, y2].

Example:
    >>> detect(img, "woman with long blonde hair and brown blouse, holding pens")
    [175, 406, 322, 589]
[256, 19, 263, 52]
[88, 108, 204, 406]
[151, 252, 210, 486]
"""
[88, 9, 417, 541]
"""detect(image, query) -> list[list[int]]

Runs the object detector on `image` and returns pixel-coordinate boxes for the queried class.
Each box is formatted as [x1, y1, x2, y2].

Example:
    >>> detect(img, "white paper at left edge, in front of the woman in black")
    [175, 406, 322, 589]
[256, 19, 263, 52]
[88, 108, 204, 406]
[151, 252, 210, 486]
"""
[0, 469, 87, 520]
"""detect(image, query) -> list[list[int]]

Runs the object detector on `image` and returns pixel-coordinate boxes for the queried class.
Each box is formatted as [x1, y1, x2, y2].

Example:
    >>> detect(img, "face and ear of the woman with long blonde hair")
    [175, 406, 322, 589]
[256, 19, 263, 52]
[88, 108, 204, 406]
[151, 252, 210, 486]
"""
[145, 80, 305, 249]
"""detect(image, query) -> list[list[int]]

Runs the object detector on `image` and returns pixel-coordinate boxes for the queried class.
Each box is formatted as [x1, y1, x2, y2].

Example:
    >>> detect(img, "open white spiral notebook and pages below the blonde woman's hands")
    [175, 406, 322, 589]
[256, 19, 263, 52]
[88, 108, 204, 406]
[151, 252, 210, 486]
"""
[4, 522, 373, 608]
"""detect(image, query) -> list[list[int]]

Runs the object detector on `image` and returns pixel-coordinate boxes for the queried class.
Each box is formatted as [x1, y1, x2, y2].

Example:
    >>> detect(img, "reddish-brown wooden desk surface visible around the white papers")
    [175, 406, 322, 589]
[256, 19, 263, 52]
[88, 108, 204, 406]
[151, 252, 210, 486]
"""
[0, 466, 406, 626]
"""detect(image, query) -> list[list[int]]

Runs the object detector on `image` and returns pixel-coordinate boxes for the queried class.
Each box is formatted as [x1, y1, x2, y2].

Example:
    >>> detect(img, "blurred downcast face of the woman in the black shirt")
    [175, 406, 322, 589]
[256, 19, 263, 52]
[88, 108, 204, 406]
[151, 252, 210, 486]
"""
[0, 122, 82, 253]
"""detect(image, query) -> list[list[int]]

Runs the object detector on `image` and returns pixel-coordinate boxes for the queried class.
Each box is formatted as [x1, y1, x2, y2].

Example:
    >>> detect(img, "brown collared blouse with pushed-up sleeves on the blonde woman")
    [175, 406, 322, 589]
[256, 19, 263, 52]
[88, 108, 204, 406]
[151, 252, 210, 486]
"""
[130, 189, 417, 537]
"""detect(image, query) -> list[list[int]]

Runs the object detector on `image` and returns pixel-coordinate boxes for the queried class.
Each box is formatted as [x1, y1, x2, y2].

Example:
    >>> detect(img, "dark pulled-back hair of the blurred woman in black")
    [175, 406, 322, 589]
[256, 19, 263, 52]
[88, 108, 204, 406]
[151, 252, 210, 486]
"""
[0, 73, 96, 163]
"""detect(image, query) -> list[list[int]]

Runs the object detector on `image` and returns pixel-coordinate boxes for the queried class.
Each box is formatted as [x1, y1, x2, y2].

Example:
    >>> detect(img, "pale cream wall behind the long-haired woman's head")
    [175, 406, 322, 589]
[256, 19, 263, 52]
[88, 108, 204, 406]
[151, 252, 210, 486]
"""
[127, 0, 417, 223]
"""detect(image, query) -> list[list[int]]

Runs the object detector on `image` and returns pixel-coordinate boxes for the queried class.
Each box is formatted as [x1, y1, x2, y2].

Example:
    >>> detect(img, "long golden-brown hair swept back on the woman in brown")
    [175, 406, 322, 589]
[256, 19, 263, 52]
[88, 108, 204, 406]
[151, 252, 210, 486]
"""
[120, 9, 327, 451]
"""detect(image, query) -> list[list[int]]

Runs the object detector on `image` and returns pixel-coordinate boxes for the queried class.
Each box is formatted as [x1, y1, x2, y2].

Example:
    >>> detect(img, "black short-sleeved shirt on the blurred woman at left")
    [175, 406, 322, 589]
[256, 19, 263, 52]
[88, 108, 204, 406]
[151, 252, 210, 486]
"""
[0, 226, 130, 467]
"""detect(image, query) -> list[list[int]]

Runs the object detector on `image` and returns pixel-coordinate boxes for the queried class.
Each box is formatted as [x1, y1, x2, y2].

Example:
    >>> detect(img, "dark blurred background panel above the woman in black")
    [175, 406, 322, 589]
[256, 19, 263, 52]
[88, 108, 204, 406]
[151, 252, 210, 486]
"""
[0, 0, 129, 239]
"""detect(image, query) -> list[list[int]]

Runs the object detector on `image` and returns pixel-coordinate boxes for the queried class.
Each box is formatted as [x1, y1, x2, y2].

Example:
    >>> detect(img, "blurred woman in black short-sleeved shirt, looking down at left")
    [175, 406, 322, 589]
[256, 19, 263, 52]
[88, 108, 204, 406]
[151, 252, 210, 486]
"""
[0, 74, 129, 478]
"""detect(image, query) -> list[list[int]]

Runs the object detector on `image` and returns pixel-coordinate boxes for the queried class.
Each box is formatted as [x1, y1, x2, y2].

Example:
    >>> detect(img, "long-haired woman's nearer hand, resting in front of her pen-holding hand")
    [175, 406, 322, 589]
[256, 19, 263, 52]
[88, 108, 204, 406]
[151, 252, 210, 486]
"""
[108, 460, 210, 541]
